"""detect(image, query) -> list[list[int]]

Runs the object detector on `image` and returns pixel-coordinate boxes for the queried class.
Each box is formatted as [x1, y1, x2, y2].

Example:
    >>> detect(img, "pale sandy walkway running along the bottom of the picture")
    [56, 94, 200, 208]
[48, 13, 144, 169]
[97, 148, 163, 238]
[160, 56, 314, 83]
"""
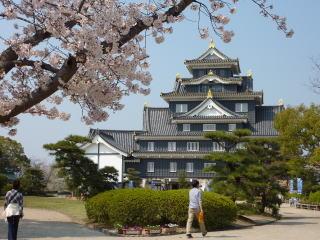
[0, 206, 320, 240]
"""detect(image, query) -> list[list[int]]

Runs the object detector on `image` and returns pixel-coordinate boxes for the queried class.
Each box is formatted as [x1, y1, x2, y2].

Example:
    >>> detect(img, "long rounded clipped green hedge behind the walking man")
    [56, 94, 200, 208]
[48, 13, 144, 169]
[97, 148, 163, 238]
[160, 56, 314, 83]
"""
[86, 189, 237, 229]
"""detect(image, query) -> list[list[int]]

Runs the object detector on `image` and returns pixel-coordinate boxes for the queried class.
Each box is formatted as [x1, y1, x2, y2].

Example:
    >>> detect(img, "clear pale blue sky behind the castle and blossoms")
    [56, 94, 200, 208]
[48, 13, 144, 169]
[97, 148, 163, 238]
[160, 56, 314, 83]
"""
[0, 0, 320, 161]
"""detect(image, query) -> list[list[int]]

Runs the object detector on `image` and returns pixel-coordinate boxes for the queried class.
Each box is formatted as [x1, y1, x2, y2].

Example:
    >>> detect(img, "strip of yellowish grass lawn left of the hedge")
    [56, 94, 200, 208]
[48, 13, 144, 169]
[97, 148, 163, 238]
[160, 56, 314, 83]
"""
[0, 196, 87, 222]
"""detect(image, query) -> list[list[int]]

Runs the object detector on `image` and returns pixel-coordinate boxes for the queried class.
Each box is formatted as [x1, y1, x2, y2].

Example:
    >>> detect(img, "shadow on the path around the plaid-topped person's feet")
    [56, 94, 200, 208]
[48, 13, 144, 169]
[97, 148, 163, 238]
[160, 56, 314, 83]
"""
[0, 219, 104, 239]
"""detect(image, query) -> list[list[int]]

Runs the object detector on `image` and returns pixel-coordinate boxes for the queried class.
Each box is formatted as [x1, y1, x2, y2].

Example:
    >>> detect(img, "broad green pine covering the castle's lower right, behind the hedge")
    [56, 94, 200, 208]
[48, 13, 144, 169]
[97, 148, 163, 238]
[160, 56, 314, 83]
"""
[205, 130, 287, 213]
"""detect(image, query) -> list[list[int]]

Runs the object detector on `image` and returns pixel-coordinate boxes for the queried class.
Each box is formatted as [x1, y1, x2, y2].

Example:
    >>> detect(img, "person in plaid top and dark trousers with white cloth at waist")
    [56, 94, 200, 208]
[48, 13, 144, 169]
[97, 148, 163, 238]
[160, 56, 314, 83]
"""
[4, 180, 23, 240]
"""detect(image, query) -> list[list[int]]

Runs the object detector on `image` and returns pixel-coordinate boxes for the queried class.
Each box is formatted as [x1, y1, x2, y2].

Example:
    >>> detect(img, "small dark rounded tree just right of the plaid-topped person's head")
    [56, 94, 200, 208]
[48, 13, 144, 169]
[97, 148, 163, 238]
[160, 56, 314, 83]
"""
[20, 166, 46, 195]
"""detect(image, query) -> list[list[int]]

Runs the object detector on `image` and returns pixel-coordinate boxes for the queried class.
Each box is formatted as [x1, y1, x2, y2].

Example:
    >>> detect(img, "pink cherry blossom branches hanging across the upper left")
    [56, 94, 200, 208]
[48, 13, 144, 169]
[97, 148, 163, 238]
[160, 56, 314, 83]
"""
[0, 0, 293, 134]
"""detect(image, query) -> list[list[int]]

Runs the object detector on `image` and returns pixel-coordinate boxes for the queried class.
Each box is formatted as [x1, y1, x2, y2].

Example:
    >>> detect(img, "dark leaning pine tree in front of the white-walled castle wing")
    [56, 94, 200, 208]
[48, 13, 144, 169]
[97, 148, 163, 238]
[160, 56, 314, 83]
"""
[44, 135, 105, 197]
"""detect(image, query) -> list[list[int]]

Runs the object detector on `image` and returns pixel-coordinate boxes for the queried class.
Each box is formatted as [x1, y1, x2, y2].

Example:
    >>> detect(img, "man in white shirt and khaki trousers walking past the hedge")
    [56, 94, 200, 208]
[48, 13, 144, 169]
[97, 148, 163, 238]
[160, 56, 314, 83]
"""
[186, 180, 207, 238]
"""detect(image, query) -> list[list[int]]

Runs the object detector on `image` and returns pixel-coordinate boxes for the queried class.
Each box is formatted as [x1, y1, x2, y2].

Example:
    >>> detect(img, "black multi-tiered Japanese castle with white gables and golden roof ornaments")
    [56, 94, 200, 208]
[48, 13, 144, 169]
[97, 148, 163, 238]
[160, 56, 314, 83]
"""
[83, 43, 283, 188]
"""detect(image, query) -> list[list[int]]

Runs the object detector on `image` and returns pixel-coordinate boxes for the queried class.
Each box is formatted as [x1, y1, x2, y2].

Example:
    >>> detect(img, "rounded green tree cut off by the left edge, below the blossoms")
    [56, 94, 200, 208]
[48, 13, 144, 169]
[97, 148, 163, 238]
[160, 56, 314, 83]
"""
[0, 136, 30, 174]
